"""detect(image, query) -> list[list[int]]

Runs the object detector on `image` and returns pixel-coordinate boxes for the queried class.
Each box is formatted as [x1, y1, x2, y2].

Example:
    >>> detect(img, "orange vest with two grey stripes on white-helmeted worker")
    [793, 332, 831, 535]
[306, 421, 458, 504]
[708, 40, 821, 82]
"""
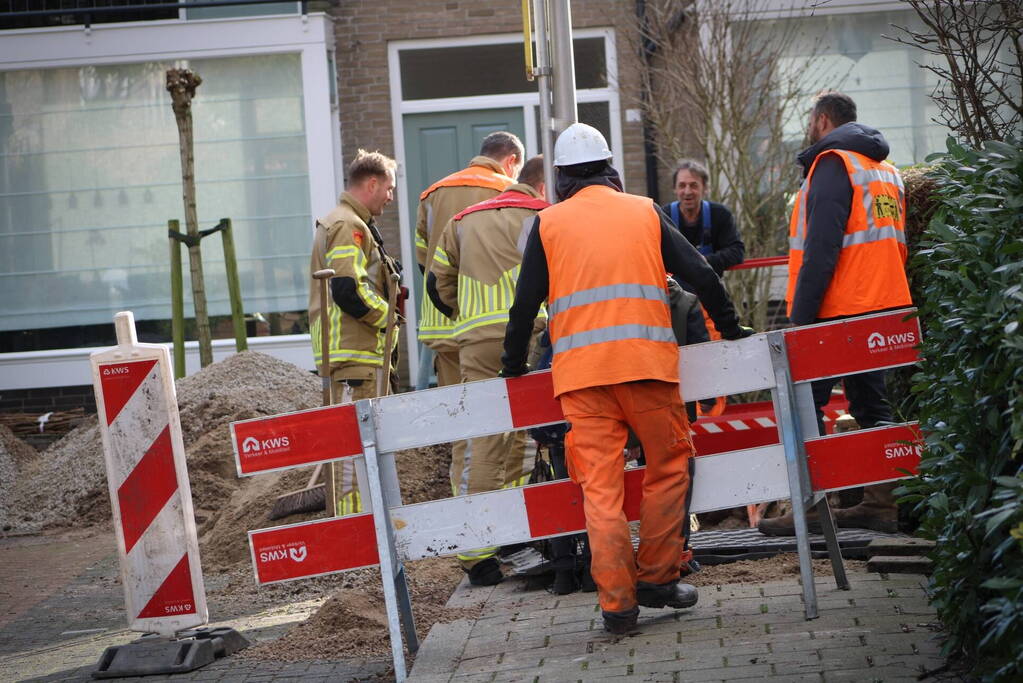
[539, 185, 678, 396]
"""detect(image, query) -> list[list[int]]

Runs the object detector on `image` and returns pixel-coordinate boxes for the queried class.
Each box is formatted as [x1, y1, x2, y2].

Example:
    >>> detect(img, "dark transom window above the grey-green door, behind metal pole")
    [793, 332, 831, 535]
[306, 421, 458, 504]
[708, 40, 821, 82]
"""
[399, 38, 608, 100]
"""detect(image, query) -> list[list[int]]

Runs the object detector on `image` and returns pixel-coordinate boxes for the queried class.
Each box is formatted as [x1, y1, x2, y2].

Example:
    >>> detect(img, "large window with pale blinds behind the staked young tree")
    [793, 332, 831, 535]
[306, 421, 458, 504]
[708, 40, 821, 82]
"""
[0, 54, 311, 330]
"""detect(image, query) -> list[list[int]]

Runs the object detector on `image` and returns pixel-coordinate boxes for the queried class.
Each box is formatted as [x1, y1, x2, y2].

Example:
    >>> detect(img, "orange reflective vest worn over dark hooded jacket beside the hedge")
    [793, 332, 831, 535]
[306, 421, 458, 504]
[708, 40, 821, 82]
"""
[786, 149, 913, 318]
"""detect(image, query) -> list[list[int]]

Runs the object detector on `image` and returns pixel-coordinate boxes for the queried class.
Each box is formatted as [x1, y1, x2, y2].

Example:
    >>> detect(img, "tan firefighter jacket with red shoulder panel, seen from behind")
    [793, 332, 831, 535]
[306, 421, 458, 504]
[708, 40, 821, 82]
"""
[433, 184, 549, 345]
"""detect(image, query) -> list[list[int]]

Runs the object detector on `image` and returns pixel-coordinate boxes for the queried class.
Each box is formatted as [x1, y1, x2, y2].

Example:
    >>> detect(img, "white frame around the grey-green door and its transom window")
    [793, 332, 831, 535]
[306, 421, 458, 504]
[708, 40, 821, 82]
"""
[388, 28, 625, 380]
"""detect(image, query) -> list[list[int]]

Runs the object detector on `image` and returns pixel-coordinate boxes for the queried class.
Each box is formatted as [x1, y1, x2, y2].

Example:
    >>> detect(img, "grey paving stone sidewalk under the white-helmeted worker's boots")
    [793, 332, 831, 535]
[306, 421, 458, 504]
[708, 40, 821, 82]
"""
[411, 573, 958, 683]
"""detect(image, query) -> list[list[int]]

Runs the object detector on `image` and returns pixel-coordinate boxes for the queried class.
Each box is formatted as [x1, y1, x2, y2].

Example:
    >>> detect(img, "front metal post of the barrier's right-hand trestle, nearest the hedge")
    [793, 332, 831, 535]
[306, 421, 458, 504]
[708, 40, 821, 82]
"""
[767, 331, 818, 619]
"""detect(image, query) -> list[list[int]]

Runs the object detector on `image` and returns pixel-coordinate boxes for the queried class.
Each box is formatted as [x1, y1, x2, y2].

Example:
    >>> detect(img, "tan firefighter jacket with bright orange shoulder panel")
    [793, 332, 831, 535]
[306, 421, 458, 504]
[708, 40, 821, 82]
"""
[415, 156, 515, 350]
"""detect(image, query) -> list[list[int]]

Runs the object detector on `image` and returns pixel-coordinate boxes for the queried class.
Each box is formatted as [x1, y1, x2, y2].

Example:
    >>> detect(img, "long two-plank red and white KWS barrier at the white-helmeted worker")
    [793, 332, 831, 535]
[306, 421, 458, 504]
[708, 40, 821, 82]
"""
[231, 310, 921, 679]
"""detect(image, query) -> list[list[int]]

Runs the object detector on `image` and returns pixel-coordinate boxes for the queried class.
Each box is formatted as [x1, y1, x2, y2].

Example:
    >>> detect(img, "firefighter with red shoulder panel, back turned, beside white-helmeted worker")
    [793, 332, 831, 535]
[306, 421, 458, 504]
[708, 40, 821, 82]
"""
[428, 156, 548, 586]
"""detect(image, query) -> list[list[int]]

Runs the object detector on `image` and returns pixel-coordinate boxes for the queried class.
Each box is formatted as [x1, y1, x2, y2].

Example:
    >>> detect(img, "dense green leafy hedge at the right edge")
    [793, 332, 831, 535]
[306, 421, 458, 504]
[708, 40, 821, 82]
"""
[903, 139, 1023, 681]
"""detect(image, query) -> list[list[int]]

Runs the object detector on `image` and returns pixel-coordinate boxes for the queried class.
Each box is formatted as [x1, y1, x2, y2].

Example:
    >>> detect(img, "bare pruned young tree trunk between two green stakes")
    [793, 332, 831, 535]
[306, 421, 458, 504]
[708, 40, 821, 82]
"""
[167, 69, 213, 367]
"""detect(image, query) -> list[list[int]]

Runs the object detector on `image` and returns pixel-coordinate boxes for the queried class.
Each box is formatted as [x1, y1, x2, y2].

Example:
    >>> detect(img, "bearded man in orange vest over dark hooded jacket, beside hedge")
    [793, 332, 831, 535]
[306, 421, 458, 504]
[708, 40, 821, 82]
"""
[757, 91, 913, 536]
